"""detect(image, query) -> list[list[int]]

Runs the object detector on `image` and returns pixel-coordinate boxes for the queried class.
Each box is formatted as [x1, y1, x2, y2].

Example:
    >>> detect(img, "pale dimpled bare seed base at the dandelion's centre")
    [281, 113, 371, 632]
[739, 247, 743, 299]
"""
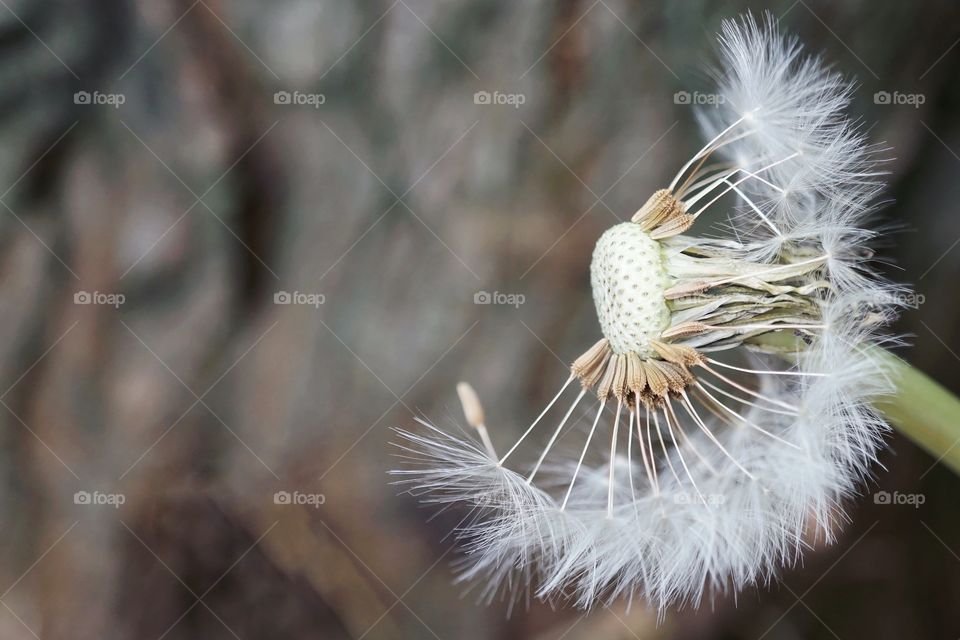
[590, 222, 670, 358]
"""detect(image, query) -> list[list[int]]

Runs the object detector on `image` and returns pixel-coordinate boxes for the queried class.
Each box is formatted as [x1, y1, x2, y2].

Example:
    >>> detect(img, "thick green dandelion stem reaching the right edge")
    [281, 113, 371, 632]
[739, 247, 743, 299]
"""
[874, 349, 960, 474]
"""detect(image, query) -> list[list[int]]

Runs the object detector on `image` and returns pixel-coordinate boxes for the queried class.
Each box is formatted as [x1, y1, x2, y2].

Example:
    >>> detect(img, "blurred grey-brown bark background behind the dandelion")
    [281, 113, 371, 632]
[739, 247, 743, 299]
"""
[0, 0, 960, 640]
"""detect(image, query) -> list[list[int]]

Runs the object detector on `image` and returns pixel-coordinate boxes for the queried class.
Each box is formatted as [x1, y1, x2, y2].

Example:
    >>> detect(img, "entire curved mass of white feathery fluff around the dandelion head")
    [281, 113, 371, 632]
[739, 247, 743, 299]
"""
[397, 17, 901, 611]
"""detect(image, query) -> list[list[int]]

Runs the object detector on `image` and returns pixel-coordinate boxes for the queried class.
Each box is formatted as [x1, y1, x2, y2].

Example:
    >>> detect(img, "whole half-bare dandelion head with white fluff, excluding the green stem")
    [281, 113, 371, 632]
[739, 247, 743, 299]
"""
[396, 12, 902, 611]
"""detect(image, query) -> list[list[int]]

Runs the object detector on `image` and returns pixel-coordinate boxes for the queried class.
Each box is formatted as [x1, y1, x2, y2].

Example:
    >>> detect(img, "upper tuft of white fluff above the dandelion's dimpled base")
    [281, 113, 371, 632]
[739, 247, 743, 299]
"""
[698, 15, 885, 280]
